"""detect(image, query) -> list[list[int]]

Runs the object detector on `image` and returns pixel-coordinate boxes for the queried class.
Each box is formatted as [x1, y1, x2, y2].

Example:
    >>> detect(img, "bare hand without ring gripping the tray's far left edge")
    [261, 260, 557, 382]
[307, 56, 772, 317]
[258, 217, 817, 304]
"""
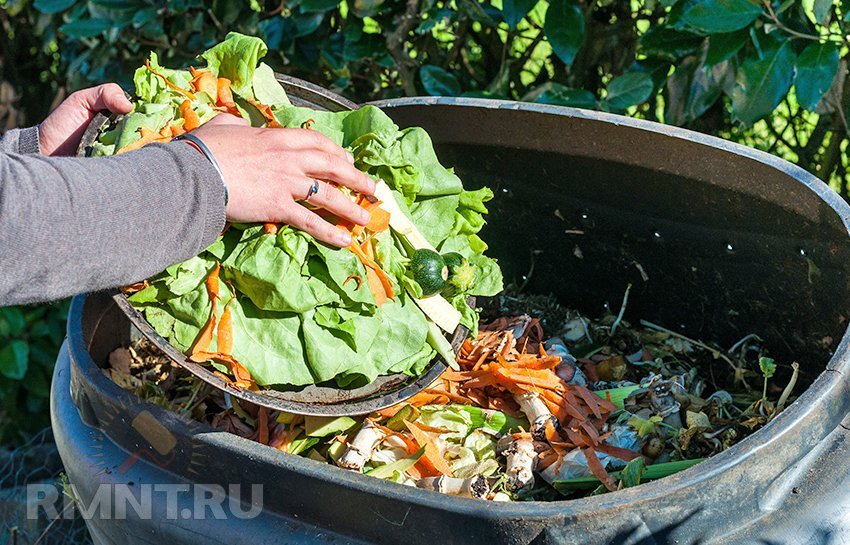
[38, 83, 133, 156]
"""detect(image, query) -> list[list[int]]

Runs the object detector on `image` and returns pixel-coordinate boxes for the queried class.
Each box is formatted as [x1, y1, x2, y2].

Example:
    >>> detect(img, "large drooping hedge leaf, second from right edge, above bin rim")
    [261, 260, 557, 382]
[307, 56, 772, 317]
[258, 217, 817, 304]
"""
[732, 42, 795, 126]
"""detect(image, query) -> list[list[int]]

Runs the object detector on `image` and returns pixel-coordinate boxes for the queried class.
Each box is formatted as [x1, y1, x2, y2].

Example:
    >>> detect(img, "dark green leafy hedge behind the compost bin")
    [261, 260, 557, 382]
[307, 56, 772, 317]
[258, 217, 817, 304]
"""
[0, 0, 850, 442]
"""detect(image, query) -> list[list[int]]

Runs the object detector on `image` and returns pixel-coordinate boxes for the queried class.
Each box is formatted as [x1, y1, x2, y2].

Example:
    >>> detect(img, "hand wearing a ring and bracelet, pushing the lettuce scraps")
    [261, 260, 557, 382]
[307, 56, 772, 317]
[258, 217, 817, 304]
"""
[187, 121, 375, 247]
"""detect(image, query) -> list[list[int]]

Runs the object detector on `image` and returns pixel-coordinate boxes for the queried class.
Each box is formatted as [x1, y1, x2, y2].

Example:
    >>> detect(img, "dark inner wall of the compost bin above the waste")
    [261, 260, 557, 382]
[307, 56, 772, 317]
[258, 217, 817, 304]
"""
[374, 100, 850, 386]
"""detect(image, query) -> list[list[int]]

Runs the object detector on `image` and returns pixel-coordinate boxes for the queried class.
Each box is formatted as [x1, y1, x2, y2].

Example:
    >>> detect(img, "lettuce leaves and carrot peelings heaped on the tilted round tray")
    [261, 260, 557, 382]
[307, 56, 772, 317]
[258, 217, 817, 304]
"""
[99, 33, 502, 389]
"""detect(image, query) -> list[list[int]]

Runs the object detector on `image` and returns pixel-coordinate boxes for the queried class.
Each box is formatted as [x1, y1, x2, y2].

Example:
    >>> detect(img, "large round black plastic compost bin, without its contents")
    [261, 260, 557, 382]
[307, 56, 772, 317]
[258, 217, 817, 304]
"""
[51, 86, 850, 545]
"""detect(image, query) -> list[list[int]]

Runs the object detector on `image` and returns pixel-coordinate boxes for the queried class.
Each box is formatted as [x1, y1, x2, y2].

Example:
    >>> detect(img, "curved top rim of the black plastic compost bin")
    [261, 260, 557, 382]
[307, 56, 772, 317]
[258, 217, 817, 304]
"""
[68, 88, 850, 510]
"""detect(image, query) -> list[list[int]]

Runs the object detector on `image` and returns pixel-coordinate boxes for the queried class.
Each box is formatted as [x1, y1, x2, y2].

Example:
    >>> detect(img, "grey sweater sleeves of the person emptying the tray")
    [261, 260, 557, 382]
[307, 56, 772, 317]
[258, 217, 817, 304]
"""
[0, 130, 225, 306]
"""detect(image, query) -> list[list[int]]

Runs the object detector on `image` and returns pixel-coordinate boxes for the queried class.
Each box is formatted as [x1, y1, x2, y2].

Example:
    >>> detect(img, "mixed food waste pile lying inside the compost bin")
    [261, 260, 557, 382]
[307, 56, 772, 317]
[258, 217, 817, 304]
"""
[105, 290, 798, 501]
